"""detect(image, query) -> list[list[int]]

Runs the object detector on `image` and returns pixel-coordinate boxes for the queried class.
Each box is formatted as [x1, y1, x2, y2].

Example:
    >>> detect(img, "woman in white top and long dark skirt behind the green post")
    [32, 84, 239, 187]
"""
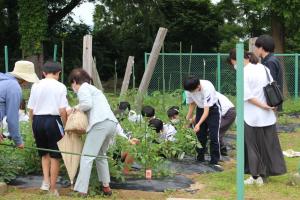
[229, 50, 286, 185]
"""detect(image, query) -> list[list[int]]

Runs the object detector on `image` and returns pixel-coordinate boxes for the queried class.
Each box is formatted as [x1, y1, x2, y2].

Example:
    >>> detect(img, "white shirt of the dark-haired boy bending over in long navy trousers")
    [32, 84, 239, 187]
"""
[186, 80, 218, 108]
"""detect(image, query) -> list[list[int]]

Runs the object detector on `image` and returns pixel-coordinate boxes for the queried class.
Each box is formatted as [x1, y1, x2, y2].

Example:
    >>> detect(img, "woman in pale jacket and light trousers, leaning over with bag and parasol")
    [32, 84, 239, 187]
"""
[69, 68, 118, 195]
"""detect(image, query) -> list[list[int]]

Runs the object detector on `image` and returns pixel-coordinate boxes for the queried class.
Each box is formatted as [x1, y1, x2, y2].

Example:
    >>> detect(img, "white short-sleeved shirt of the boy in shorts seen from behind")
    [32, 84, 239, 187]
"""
[28, 78, 68, 115]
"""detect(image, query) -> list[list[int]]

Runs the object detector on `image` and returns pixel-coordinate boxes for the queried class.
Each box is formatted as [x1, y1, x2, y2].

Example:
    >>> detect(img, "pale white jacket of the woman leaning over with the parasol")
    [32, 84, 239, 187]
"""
[76, 83, 118, 132]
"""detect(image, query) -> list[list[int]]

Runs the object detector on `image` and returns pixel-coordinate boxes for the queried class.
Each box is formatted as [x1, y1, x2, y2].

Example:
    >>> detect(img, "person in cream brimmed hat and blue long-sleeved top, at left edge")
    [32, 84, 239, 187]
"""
[0, 61, 39, 148]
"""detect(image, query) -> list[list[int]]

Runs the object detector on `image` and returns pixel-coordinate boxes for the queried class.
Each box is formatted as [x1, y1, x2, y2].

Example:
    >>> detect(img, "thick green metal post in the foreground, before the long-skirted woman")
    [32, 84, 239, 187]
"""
[236, 43, 245, 200]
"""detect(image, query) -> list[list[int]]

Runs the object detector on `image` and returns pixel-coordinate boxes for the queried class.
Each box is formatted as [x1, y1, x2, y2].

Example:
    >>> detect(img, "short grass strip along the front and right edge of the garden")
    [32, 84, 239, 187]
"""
[0, 133, 300, 200]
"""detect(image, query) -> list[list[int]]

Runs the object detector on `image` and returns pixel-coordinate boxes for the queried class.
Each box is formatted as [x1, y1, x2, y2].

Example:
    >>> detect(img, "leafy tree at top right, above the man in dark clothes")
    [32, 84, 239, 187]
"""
[238, 0, 300, 53]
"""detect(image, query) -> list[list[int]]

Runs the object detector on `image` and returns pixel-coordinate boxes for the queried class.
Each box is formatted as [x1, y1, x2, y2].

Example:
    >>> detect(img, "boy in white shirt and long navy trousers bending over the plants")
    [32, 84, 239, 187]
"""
[183, 77, 221, 170]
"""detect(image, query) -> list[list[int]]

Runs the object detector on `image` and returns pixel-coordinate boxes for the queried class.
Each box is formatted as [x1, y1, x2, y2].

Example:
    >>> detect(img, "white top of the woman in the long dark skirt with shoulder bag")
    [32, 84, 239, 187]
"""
[244, 63, 276, 127]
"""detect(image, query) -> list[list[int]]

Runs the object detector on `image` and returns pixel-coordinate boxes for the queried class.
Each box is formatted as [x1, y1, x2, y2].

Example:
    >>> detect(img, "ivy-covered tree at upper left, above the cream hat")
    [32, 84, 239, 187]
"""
[18, 0, 94, 76]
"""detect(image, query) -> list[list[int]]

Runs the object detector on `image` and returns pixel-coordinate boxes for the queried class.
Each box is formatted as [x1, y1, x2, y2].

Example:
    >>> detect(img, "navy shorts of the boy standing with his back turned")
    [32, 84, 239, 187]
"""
[32, 115, 63, 158]
